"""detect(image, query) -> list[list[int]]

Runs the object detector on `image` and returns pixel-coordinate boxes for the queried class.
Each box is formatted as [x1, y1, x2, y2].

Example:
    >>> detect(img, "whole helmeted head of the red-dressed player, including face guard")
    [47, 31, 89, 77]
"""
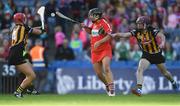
[88, 8, 102, 22]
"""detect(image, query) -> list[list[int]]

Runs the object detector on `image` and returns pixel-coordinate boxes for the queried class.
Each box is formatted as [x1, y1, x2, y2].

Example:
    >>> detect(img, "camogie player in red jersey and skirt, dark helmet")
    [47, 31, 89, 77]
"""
[81, 8, 115, 96]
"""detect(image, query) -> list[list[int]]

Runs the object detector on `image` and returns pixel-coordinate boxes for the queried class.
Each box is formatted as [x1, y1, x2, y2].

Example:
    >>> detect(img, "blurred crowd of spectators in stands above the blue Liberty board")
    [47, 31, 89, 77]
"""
[0, 0, 180, 61]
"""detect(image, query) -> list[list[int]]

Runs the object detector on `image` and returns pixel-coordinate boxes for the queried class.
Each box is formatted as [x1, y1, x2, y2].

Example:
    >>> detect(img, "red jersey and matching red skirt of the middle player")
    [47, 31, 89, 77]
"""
[90, 19, 112, 63]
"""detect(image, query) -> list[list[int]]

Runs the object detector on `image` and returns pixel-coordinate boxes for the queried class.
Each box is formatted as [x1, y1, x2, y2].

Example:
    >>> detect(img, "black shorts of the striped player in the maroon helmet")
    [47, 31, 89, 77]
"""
[141, 52, 165, 64]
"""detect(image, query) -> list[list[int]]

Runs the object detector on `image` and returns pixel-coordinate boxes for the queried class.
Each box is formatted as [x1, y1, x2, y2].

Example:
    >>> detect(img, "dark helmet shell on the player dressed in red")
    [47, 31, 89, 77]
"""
[88, 8, 103, 19]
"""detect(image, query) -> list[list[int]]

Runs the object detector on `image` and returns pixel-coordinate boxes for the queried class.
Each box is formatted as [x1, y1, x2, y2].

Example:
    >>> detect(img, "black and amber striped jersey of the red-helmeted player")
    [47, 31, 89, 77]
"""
[11, 24, 32, 47]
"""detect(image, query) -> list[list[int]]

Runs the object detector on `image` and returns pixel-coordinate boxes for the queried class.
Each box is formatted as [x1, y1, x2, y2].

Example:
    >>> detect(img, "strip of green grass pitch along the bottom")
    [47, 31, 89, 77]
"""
[0, 94, 180, 106]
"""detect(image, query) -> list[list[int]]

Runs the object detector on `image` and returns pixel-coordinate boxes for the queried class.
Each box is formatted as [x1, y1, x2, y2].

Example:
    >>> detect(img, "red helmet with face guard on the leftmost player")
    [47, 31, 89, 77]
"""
[13, 13, 26, 24]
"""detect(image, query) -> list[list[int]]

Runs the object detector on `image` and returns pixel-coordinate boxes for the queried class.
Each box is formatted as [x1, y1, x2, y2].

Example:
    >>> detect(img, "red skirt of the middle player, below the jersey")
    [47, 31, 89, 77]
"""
[91, 49, 112, 64]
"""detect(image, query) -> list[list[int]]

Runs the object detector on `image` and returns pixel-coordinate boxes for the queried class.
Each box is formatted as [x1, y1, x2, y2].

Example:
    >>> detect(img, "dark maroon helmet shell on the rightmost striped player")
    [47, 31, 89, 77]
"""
[136, 16, 150, 25]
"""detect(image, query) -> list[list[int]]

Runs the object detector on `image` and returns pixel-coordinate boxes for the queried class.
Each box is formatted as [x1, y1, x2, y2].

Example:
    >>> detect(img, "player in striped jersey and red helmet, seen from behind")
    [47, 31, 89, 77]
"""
[8, 13, 44, 98]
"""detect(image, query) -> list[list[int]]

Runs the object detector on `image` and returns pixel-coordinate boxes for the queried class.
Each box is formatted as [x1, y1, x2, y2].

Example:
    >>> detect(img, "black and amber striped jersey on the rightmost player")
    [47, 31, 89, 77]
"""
[131, 27, 161, 54]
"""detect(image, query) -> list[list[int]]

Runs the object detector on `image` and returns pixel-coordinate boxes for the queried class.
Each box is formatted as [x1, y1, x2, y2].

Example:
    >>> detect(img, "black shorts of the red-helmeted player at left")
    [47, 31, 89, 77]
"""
[8, 44, 26, 65]
